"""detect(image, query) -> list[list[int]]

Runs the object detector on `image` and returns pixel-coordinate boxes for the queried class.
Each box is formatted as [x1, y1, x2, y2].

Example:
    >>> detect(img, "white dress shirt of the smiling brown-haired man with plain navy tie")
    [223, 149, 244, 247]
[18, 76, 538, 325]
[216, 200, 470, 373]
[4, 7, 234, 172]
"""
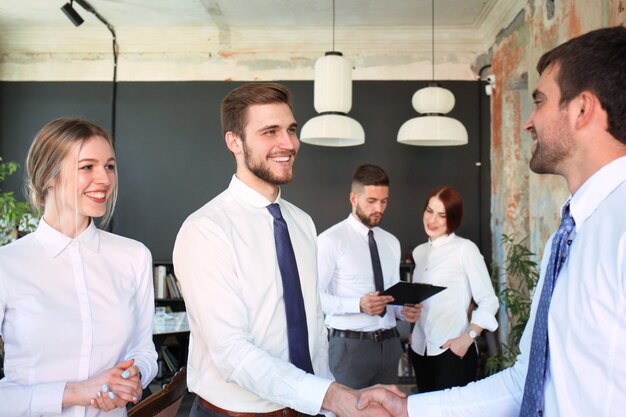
[174, 176, 332, 415]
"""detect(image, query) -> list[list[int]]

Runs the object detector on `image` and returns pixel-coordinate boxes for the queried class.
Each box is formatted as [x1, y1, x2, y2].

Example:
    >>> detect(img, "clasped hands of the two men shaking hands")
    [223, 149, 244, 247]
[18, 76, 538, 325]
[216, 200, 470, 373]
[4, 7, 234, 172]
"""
[322, 382, 408, 417]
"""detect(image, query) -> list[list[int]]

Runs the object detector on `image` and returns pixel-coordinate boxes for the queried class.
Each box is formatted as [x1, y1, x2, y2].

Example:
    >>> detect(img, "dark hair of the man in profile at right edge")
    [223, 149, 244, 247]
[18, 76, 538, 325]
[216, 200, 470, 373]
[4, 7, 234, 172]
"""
[537, 26, 626, 144]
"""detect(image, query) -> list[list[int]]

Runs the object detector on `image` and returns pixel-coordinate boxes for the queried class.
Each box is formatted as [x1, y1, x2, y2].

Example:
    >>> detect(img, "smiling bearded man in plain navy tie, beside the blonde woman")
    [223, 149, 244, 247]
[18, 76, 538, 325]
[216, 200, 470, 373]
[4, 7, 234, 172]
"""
[174, 83, 400, 417]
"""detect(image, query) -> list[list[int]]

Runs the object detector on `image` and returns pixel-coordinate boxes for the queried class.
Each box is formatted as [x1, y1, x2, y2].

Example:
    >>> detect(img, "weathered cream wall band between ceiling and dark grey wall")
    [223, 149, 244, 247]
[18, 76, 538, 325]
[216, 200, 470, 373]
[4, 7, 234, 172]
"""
[0, 26, 486, 81]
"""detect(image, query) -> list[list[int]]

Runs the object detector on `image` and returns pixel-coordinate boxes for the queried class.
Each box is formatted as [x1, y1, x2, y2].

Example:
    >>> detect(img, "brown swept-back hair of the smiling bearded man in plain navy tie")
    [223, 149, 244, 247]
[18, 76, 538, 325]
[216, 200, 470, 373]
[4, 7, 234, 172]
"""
[220, 83, 293, 140]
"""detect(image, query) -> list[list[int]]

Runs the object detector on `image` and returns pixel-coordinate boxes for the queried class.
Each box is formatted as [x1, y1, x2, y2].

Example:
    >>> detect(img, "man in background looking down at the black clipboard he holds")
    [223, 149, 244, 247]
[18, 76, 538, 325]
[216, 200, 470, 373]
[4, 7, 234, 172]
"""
[318, 165, 421, 389]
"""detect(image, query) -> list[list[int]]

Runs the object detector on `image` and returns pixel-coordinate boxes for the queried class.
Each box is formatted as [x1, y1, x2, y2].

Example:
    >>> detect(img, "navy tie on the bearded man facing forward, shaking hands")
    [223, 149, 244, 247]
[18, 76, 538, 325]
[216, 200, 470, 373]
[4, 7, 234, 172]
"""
[267, 203, 313, 374]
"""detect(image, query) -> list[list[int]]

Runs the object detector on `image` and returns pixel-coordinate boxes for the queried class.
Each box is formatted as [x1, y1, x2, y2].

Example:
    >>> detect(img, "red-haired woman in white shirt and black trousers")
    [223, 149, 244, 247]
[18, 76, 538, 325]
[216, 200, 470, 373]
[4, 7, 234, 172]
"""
[411, 186, 498, 392]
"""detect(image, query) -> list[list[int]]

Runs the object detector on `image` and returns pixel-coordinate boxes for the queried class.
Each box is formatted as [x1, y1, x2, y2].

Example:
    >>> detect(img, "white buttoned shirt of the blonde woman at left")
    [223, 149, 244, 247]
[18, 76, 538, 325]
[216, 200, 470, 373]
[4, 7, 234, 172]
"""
[0, 219, 157, 417]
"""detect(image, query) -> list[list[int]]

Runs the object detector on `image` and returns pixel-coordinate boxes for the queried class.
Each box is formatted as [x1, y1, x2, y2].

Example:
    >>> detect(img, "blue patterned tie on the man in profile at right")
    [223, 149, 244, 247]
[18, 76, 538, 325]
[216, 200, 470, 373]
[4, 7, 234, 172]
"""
[519, 202, 576, 417]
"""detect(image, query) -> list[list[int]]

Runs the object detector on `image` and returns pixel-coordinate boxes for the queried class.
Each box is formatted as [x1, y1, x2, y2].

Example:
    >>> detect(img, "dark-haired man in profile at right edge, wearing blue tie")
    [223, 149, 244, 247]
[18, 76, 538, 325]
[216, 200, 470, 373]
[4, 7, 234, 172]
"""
[362, 26, 626, 417]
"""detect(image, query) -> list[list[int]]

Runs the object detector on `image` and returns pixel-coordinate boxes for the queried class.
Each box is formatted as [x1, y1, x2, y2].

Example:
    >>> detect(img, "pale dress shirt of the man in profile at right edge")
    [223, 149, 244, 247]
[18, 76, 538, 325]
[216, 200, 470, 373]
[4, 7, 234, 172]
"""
[408, 157, 626, 417]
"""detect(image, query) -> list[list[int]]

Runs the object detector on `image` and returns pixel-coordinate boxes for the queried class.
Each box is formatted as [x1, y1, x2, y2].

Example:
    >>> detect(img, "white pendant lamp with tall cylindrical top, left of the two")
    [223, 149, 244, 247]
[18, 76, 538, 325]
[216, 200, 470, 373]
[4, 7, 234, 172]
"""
[300, 0, 365, 146]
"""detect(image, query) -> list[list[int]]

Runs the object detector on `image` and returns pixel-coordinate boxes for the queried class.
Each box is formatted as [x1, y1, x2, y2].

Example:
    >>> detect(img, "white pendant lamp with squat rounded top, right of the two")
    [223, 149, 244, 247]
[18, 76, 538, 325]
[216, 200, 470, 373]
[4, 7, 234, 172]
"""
[398, 0, 467, 146]
